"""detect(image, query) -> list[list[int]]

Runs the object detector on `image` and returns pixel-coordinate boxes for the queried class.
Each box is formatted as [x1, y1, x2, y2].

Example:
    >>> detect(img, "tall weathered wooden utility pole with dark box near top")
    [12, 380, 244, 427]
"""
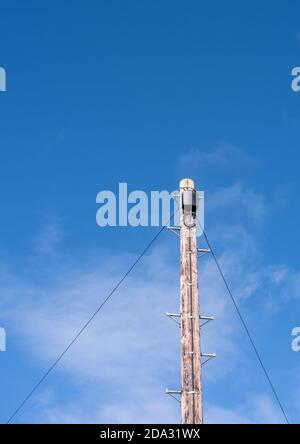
[179, 179, 203, 424]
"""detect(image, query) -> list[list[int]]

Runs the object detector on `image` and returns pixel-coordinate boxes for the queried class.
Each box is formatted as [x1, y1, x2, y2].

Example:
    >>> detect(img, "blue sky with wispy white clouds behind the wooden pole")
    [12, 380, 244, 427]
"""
[0, 0, 300, 422]
